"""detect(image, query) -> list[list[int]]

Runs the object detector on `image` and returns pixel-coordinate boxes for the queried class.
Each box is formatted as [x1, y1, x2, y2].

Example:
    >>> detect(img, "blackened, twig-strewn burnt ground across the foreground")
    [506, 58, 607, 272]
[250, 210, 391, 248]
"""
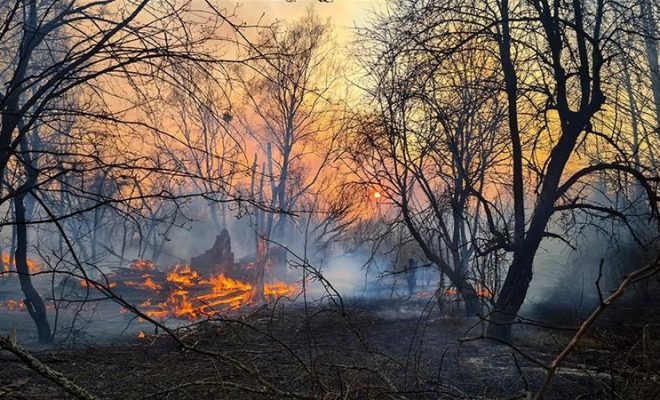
[0, 300, 660, 400]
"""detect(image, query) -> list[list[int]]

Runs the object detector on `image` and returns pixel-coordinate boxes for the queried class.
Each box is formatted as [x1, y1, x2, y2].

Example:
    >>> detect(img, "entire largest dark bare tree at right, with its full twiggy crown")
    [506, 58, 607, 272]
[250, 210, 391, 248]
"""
[360, 0, 657, 339]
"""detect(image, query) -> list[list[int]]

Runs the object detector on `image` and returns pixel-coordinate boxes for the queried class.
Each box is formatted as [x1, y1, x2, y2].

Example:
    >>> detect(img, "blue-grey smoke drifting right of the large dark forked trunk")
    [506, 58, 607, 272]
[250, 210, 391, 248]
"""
[522, 216, 658, 321]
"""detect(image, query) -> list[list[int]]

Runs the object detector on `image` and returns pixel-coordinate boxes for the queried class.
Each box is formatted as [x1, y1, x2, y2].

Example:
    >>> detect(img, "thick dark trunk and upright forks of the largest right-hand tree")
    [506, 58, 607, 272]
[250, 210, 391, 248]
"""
[488, 0, 605, 340]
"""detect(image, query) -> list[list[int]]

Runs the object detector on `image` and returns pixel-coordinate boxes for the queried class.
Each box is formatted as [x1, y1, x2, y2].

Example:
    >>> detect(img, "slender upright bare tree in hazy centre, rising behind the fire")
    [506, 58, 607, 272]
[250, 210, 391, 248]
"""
[242, 11, 338, 245]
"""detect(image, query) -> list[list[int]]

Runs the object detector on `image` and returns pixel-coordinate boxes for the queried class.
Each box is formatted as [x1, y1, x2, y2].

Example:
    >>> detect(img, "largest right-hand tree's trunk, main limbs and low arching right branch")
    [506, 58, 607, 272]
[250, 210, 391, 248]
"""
[488, 0, 657, 340]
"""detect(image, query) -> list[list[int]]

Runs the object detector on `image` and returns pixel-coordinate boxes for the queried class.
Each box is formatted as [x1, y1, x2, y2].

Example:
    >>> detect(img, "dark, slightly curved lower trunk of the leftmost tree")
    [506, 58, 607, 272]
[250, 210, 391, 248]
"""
[14, 193, 52, 344]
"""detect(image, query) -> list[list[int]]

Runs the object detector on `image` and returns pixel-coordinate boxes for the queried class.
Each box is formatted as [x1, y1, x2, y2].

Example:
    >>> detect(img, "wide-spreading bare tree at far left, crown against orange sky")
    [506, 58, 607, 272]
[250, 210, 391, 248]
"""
[0, 0, 262, 341]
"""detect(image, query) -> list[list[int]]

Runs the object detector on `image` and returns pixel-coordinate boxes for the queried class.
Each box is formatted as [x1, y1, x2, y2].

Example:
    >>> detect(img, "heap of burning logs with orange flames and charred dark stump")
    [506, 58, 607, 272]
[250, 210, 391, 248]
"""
[64, 230, 298, 320]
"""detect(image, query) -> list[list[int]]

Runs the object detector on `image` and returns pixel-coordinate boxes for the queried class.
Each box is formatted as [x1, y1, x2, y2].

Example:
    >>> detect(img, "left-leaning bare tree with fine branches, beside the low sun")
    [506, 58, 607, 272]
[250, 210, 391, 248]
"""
[354, 13, 504, 315]
